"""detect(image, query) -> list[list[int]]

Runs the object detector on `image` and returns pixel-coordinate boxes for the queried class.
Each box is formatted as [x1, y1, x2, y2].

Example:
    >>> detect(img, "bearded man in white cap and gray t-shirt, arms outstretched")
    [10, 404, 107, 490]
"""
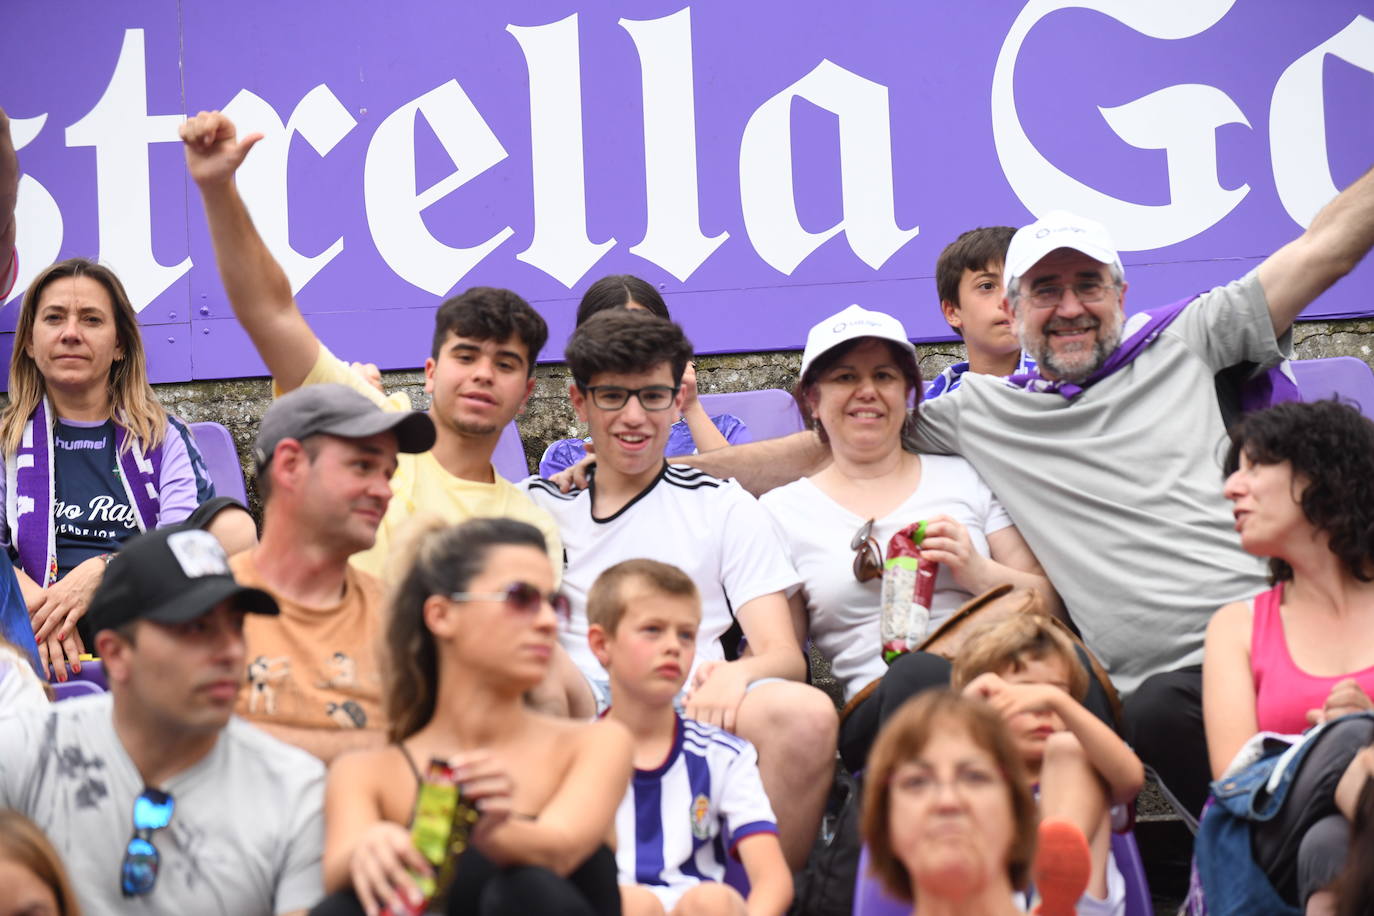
[686, 172, 1374, 813]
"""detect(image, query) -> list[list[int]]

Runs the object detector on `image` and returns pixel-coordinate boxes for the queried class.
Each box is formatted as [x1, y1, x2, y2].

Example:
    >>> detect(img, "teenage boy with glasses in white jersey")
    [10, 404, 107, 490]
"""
[526, 309, 837, 869]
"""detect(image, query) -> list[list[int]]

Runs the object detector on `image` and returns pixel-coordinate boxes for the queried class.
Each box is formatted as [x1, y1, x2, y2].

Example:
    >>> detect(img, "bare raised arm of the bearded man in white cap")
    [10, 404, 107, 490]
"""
[1260, 162, 1374, 335]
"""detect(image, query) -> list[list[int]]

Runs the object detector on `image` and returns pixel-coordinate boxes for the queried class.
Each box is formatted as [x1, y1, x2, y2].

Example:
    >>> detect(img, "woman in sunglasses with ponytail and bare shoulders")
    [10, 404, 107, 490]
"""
[312, 519, 632, 916]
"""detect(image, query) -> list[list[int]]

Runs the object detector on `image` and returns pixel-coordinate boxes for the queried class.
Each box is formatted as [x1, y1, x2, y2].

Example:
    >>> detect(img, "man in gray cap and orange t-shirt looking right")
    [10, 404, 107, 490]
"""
[231, 383, 434, 762]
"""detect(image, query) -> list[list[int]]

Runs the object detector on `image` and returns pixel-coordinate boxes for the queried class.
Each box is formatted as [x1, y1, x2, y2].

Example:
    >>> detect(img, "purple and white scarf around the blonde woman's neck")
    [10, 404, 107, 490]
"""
[5, 398, 162, 588]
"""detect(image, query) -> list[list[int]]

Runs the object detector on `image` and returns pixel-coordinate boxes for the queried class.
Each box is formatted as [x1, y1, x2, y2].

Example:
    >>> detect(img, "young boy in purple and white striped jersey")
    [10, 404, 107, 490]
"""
[587, 559, 791, 916]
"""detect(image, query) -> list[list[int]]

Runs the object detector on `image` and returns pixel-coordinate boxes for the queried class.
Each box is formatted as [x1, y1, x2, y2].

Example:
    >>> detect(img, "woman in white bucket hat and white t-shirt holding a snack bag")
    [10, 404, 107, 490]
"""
[760, 305, 1063, 769]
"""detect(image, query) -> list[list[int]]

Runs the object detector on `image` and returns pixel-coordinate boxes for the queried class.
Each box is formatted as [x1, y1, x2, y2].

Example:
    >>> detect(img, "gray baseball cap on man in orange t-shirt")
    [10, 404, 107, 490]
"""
[253, 382, 434, 471]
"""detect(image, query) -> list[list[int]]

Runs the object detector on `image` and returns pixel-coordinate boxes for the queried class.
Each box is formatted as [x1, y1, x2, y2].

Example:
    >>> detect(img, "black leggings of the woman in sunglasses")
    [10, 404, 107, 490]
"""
[311, 846, 620, 916]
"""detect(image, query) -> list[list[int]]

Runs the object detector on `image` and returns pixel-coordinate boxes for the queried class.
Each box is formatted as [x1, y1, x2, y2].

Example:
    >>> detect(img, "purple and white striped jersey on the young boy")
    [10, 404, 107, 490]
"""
[616, 715, 778, 909]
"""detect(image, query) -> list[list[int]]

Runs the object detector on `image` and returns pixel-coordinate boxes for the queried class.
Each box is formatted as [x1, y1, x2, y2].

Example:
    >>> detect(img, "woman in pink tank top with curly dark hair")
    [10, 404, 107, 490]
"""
[1202, 401, 1374, 913]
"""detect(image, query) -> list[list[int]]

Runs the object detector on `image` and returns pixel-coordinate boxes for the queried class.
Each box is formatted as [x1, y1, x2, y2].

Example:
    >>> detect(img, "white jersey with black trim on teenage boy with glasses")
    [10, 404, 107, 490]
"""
[523, 464, 797, 680]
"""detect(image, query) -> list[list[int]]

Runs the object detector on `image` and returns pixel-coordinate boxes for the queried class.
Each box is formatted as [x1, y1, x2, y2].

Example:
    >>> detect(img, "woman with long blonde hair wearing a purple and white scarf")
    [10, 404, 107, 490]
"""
[0, 258, 257, 680]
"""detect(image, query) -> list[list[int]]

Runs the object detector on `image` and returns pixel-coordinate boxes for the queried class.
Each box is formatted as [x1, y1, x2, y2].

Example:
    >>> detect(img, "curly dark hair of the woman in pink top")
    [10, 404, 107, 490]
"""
[1224, 398, 1374, 582]
